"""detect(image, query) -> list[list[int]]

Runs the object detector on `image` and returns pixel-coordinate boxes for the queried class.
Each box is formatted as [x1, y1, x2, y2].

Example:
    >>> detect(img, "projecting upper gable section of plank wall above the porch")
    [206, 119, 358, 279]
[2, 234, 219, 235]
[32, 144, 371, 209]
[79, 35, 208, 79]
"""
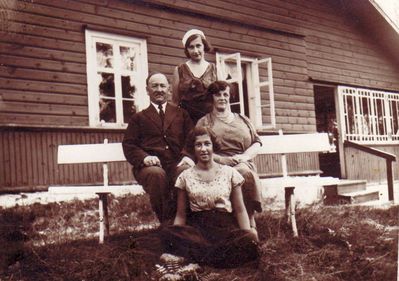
[147, 0, 399, 91]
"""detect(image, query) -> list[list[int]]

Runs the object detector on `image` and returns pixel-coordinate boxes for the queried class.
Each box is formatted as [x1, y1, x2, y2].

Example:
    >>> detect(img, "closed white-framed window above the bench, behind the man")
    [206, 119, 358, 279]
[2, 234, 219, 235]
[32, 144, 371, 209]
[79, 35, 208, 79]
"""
[86, 30, 149, 128]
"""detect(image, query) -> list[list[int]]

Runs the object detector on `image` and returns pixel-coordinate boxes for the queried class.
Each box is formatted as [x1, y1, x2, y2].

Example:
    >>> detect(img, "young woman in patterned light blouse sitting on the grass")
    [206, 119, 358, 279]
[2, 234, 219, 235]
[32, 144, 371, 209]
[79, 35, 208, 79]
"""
[161, 127, 258, 267]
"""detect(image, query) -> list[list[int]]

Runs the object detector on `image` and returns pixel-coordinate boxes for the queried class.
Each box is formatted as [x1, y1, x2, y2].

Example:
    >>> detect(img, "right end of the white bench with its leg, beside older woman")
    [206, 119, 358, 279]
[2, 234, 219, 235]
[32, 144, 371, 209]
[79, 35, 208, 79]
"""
[258, 130, 335, 237]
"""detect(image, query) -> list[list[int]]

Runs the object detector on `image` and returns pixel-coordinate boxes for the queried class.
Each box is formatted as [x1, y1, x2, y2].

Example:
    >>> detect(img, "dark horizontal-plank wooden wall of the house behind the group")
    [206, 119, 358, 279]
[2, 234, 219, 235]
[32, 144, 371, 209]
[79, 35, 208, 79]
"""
[0, 0, 399, 188]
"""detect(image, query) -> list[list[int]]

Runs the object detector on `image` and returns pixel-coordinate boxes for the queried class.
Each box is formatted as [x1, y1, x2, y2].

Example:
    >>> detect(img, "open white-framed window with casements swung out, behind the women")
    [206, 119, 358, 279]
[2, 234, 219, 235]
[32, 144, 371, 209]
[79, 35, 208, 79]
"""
[216, 53, 276, 130]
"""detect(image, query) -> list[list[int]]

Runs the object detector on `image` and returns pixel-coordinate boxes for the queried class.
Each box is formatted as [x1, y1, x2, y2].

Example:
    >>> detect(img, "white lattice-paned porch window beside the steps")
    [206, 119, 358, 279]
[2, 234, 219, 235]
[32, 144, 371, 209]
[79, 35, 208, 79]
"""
[338, 86, 399, 143]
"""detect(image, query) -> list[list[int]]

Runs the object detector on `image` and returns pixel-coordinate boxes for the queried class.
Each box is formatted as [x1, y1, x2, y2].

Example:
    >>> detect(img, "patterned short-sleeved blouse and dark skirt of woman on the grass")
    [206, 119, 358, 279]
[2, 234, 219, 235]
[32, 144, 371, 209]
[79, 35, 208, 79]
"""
[161, 165, 258, 267]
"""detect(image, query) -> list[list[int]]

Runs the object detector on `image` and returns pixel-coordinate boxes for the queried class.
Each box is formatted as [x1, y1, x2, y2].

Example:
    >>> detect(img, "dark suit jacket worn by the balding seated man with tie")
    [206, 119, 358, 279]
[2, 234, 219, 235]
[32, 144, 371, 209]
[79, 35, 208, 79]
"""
[122, 103, 193, 170]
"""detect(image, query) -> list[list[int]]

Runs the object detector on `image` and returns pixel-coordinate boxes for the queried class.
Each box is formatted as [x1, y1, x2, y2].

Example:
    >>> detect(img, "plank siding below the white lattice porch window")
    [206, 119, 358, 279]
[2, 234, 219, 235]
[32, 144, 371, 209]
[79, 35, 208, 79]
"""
[345, 145, 399, 183]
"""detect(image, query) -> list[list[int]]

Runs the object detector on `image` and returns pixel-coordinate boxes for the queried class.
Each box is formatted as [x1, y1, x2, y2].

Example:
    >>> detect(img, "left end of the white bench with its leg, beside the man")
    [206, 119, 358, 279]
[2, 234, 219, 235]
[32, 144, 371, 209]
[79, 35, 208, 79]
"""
[57, 139, 126, 244]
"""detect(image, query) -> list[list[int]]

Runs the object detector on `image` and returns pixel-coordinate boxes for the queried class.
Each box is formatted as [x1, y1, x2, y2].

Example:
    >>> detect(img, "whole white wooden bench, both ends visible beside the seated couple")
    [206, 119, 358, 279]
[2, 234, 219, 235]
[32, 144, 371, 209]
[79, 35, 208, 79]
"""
[58, 131, 335, 243]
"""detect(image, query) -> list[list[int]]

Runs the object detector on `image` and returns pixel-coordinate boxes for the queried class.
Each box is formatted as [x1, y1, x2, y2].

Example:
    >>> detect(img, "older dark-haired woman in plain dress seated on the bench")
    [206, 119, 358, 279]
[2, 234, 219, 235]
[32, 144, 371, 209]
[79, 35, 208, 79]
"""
[197, 81, 262, 228]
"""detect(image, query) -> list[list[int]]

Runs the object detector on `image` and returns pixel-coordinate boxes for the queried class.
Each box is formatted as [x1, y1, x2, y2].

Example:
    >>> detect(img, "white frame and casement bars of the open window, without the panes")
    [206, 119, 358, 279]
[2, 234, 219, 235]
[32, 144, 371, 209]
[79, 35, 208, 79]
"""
[216, 53, 276, 131]
